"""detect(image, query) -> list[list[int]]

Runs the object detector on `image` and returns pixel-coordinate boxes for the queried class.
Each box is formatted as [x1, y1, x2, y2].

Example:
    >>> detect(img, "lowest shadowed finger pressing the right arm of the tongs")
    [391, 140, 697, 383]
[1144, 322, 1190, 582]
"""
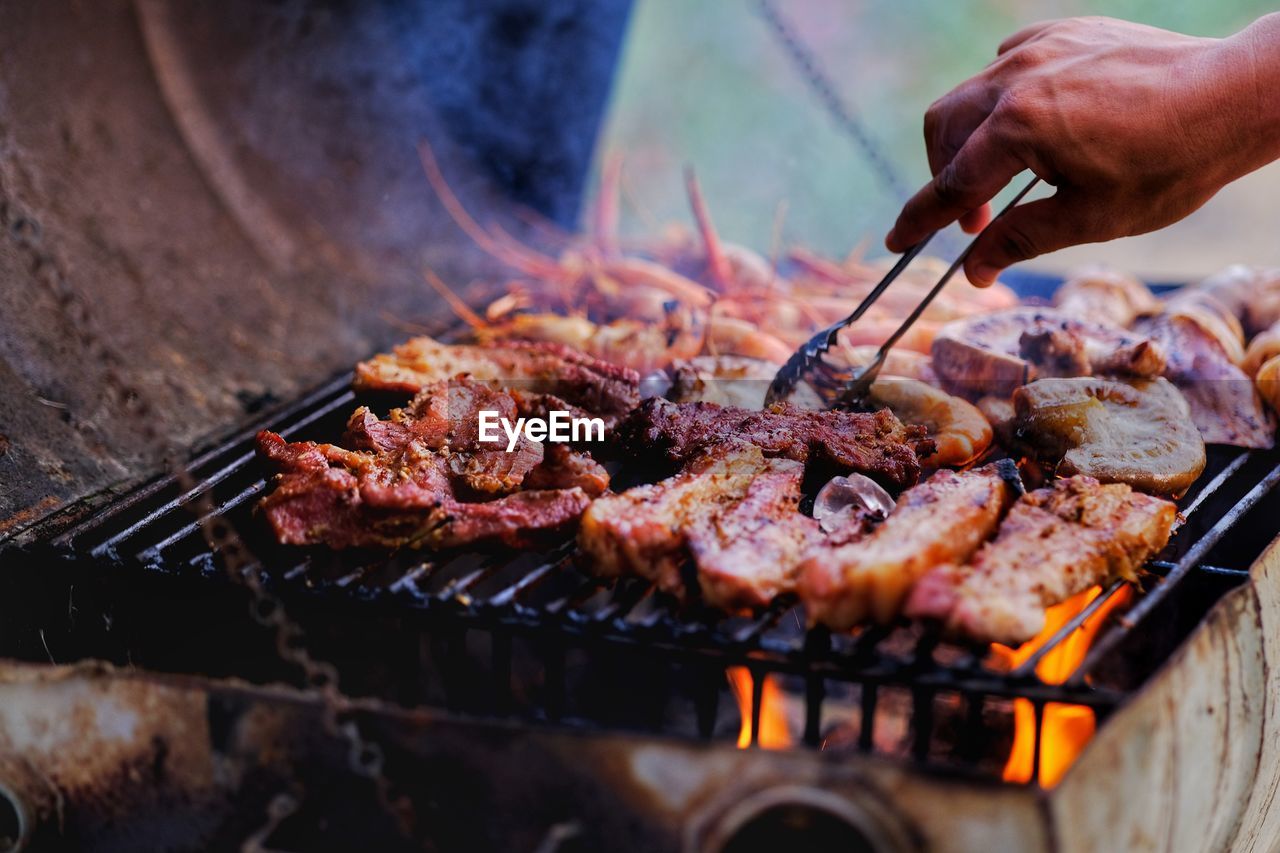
[964, 190, 1097, 287]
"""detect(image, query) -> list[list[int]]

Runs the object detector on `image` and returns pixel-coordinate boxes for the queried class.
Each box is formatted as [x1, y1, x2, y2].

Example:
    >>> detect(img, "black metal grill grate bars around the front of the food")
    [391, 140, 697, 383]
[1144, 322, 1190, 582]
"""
[51, 368, 1280, 767]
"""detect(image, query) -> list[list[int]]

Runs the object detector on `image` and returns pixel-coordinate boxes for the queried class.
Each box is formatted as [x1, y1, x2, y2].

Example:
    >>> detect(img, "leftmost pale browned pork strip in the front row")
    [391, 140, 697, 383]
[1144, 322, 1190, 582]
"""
[577, 442, 768, 594]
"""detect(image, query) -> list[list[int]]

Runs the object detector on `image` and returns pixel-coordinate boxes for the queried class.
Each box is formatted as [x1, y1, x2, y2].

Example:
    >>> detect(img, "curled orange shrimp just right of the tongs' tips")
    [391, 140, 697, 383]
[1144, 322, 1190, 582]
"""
[868, 377, 992, 467]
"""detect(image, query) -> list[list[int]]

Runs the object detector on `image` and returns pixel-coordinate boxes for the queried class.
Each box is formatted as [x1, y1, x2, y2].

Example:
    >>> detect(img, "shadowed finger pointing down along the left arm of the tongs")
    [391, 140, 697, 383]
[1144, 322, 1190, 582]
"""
[884, 123, 1025, 252]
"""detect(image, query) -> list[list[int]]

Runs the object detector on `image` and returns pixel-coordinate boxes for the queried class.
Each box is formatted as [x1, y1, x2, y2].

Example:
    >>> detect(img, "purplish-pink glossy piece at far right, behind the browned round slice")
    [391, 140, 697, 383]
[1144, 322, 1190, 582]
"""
[1142, 314, 1275, 448]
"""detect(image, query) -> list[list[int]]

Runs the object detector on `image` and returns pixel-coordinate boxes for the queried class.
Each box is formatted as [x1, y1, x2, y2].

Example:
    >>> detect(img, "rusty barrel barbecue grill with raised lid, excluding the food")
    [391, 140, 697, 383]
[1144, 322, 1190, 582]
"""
[0, 0, 1280, 852]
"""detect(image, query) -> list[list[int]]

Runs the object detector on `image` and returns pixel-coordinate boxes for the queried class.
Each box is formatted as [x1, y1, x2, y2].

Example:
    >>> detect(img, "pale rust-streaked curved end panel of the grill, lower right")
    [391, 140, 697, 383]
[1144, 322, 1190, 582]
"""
[1046, 539, 1280, 852]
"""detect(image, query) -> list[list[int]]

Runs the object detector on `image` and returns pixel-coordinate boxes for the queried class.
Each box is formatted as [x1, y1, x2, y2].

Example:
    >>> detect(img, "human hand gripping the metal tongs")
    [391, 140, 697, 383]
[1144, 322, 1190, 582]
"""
[884, 15, 1280, 287]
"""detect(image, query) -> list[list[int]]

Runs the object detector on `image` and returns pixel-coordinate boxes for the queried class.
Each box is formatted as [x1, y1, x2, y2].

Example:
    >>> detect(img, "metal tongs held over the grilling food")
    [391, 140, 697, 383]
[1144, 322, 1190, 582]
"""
[764, 177, 1039, 409]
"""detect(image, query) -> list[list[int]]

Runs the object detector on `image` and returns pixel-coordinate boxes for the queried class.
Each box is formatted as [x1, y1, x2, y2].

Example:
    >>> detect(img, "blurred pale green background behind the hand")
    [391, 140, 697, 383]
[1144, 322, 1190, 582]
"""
[596, 0, 1280, 280]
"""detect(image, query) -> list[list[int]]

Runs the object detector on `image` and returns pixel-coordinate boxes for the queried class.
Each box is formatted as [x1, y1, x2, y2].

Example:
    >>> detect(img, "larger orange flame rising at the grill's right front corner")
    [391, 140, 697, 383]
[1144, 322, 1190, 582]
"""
[991, 587, 1130, 788]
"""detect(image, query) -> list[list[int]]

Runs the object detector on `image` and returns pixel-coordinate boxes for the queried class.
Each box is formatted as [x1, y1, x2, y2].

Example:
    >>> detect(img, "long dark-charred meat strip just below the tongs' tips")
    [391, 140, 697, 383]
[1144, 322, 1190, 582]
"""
[617, 397, 933, 489]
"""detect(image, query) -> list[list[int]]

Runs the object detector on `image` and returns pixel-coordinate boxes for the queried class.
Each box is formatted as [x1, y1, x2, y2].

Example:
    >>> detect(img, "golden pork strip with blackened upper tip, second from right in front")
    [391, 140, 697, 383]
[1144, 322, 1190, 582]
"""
[797, 460, 1020, 630]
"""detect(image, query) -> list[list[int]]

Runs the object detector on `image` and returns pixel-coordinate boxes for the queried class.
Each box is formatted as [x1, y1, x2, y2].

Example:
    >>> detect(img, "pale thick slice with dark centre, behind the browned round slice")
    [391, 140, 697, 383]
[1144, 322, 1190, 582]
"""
[933, 307, 1165, 398]
